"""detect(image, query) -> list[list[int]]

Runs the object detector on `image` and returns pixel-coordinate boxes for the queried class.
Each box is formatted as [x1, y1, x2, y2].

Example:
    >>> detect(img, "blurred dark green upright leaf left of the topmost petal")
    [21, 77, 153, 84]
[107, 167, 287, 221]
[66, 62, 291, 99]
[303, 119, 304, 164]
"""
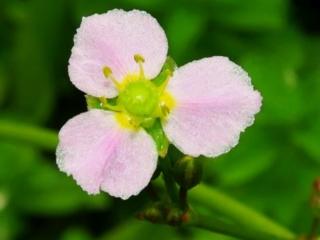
[3, 0, 66, 122]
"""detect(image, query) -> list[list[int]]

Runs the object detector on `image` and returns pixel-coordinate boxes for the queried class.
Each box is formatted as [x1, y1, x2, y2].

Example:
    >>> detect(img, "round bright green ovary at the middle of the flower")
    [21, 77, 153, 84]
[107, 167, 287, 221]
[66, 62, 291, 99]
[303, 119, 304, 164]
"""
[119, 80, 160, 117]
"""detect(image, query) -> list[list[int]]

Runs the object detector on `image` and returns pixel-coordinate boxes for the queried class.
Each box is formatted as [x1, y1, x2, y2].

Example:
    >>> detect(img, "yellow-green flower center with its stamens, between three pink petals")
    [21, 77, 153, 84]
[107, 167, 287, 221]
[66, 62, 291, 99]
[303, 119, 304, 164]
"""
[100, 54, 175, 129]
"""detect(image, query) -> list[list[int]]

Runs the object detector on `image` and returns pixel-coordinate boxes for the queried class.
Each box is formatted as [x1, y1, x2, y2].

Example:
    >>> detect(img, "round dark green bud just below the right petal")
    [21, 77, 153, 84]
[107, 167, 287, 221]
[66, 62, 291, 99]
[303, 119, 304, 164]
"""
[173, 156, 202, 189]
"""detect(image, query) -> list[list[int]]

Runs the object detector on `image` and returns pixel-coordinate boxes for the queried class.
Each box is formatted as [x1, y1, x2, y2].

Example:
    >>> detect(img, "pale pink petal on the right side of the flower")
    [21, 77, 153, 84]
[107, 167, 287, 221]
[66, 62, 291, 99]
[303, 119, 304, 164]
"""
[163, 57, 261, 157]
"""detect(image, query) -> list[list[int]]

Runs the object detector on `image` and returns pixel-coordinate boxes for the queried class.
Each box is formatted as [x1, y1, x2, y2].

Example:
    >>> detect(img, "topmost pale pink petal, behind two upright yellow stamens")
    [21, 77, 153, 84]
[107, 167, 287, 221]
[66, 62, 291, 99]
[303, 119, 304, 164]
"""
[69, 10, 168, 98]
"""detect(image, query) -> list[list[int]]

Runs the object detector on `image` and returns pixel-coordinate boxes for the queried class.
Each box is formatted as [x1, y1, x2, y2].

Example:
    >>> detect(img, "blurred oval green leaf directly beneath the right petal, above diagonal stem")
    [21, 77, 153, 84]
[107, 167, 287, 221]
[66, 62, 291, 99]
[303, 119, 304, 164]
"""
[205, 128, 276, 186]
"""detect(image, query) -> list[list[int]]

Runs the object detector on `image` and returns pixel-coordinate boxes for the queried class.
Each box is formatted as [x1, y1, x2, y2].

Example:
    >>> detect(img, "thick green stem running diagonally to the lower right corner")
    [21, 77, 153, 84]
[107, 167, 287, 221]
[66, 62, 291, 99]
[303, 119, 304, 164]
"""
[190, 184, 295, 240]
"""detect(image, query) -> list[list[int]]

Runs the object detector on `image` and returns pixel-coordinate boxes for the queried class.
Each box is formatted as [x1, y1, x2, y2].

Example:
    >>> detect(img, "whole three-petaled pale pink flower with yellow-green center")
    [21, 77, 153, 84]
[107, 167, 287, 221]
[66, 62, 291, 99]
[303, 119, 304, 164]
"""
[57, 10, 261, 199]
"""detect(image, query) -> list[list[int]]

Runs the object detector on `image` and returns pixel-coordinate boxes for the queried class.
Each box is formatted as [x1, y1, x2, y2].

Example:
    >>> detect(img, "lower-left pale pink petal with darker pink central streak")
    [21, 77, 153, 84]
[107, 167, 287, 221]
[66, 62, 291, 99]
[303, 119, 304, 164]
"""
[57, 110, 157, 199]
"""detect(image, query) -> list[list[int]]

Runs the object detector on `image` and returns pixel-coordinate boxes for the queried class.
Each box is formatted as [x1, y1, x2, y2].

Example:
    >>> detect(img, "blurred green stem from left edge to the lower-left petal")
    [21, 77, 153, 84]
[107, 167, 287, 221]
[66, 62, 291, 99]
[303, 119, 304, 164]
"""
[0, 120, 58, 151]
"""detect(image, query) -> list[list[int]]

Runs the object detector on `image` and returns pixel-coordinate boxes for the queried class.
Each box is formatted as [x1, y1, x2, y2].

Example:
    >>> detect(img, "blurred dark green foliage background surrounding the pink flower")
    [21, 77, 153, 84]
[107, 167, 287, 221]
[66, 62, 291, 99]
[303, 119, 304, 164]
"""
[0, 0, 320, 240]
